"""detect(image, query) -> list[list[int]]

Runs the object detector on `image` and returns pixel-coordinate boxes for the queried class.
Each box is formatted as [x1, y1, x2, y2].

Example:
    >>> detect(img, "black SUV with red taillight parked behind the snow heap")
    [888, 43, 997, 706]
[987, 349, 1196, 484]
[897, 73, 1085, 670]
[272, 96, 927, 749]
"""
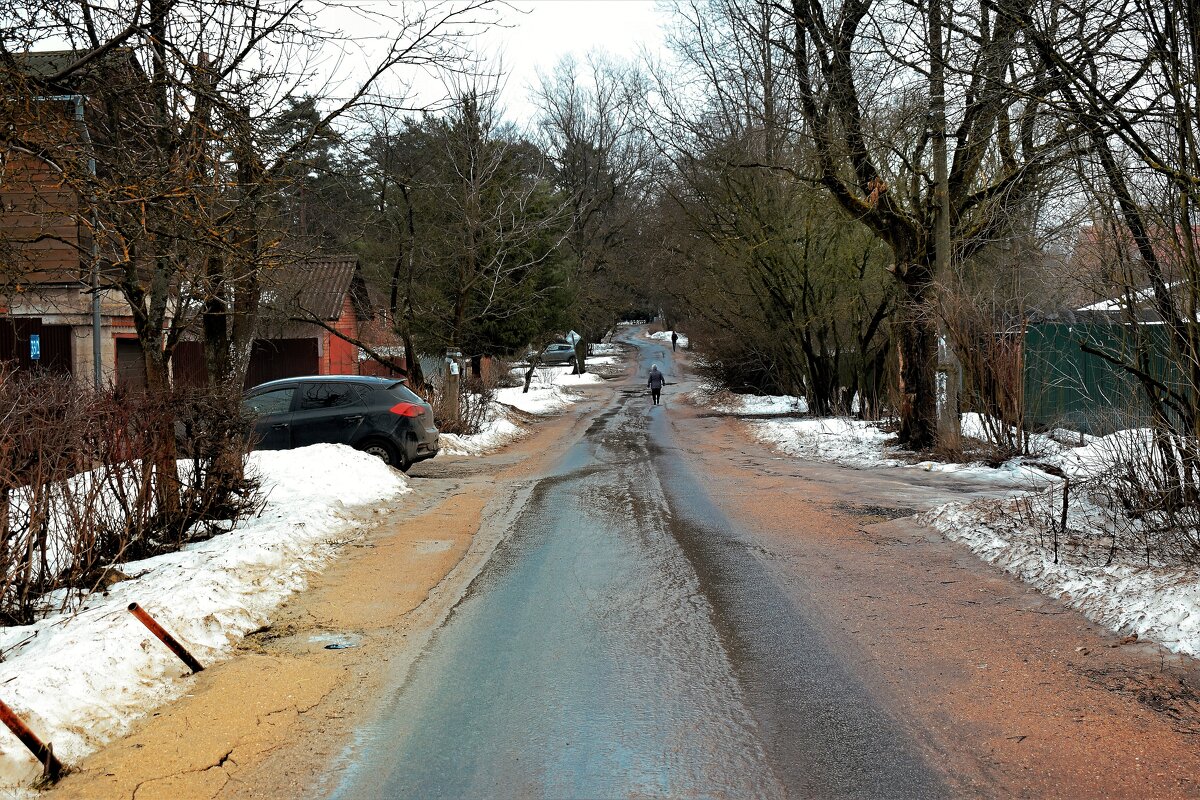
[242, 375, 438, 471]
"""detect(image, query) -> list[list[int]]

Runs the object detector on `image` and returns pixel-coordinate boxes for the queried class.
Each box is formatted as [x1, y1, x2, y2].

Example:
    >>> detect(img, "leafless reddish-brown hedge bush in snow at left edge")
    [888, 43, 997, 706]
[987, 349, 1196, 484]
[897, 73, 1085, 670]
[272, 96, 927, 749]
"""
[0, 373, 260, 624]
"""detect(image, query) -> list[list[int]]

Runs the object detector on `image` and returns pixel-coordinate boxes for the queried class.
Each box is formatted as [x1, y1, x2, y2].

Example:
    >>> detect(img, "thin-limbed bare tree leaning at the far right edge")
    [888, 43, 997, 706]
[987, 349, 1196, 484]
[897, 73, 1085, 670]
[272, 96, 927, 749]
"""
[1013, 0, 1200, 496]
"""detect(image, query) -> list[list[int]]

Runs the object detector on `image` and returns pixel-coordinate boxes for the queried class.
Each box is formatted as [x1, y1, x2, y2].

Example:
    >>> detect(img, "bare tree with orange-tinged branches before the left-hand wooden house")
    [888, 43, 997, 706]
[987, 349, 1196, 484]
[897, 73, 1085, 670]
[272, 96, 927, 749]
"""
[0, 0, 488, 513]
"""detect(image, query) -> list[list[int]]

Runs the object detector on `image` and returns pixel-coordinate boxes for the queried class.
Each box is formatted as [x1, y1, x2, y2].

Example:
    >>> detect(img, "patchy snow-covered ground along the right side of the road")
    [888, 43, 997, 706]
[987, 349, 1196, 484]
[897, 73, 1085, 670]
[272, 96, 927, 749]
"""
[696, 393, 1200, 656]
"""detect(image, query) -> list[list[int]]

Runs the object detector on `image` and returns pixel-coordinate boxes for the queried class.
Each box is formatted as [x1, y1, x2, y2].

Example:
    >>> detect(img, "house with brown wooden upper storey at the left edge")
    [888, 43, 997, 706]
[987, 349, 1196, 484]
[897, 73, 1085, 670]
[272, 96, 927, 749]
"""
[0, 50, 136, 383]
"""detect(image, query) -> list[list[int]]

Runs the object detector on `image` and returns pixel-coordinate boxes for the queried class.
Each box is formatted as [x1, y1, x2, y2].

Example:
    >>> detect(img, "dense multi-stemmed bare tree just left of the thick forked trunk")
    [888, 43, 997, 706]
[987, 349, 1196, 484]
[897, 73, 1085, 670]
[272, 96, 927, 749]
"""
[656, 0, 892, 414]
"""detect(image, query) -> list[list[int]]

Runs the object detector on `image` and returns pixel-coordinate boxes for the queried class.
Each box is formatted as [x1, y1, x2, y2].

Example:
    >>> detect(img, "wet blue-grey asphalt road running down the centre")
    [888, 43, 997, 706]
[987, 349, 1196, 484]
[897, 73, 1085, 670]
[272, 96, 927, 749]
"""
[335, 339, 948, 800]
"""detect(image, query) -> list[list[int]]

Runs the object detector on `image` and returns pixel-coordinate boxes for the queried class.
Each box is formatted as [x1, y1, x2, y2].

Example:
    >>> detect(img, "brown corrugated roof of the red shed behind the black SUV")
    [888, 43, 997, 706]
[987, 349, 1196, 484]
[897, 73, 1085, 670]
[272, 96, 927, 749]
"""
[264, 255, 371, 321]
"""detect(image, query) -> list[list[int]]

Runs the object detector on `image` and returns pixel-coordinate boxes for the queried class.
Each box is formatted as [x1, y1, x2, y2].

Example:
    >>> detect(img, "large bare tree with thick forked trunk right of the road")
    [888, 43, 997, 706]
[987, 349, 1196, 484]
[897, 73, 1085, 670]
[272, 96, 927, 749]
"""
[782, 0, 1075, 449]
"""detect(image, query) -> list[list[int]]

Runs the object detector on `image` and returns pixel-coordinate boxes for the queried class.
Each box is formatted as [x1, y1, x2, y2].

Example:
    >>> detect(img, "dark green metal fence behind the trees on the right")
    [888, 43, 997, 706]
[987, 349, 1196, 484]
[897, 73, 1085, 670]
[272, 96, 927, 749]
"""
[1025, 323, 1183, 435]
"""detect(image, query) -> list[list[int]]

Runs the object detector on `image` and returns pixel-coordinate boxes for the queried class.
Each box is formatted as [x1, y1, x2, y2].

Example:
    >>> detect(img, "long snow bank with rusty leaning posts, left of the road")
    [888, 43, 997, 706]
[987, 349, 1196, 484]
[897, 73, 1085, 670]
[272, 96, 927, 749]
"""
[0, 445, 409, 792]
